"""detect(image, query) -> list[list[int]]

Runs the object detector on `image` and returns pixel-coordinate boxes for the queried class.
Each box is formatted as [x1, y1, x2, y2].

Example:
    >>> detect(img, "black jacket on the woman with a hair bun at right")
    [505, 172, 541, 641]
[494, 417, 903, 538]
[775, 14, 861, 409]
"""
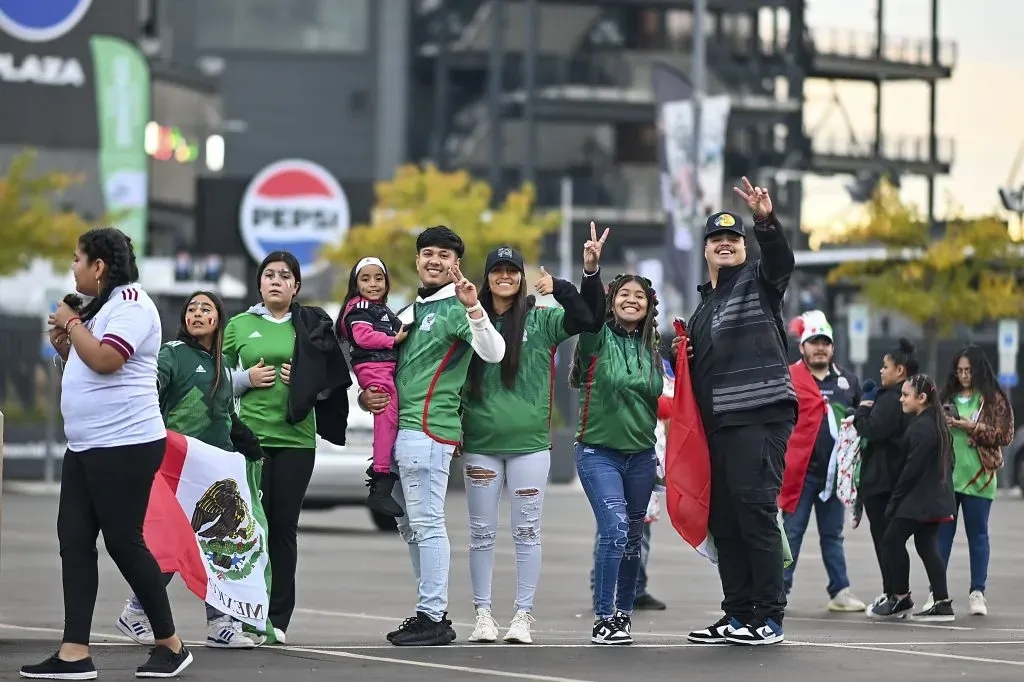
[853, 383, 909, 498]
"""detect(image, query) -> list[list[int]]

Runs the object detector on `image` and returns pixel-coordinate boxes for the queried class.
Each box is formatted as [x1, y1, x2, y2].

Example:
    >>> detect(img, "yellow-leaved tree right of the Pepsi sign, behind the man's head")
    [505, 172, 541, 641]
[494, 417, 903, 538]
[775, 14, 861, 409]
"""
[321, 164, 558, 292]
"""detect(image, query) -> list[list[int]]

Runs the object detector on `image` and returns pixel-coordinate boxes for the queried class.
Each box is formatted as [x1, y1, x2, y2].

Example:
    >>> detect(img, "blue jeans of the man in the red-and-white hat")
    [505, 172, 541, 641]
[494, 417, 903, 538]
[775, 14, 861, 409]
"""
[782, 476, 850, 597]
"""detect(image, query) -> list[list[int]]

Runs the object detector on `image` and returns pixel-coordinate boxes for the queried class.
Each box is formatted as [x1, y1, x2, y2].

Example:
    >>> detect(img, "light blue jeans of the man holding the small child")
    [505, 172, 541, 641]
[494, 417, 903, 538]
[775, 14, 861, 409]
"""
[393, 429, 455, 623]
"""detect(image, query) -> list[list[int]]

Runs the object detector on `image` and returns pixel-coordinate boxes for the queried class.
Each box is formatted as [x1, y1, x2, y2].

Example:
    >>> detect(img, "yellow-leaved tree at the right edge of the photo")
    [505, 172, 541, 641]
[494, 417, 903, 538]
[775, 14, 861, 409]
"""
[828, 182, 1024, 375]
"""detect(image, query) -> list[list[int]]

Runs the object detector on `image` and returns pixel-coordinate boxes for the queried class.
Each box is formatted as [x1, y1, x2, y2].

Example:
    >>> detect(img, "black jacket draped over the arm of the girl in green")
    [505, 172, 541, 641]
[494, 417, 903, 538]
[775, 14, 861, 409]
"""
[286, 303, 352, 445]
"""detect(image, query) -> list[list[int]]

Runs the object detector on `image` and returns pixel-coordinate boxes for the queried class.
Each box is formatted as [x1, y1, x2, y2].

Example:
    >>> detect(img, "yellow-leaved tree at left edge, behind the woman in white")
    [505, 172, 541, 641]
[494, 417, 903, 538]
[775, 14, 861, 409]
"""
[0, 152, 99, 276]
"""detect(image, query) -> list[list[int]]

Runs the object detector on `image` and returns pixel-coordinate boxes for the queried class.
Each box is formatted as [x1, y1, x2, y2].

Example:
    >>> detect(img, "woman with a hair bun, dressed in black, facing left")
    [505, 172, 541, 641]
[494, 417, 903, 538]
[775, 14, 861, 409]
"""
[853, 339, 919, 615]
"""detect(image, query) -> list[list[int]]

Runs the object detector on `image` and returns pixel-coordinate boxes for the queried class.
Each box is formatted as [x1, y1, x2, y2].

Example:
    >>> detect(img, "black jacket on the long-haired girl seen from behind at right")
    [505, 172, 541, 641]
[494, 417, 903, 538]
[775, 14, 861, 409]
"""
[886, 408, 956, 523]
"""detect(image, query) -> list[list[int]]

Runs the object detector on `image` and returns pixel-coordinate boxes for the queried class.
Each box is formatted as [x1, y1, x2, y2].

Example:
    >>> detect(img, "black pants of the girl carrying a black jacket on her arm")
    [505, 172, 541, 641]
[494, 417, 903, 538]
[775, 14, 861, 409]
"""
[260, 447, 316, 632]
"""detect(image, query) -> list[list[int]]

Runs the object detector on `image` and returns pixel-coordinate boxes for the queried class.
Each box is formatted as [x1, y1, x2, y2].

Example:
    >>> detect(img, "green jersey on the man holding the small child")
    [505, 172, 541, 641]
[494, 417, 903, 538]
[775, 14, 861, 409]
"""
[394, 285, 483, 445]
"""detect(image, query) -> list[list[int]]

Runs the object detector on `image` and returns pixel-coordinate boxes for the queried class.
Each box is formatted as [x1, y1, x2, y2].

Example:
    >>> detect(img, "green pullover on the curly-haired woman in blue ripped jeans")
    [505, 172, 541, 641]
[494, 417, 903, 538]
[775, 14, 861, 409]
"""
[577, 325, 665, 455]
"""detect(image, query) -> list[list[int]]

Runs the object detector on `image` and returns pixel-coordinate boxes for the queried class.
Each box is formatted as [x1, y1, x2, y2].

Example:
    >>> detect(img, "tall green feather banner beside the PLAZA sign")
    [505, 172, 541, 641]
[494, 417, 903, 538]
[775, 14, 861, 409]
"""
[89, 36, 150, 251]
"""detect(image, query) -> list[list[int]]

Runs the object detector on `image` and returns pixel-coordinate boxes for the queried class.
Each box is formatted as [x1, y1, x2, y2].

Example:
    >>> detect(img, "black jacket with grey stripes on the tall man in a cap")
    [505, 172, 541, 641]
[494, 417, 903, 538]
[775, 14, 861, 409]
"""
[689, 214, 797, 433]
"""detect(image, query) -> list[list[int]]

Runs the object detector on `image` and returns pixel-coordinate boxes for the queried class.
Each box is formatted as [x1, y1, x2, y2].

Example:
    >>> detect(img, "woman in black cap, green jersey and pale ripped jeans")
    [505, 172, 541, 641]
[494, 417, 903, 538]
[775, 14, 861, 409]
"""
[462, 223, 608, 644]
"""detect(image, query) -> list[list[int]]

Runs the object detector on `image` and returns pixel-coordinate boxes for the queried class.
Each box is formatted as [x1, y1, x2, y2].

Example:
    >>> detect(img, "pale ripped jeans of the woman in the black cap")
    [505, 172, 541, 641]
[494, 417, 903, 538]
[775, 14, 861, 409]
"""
[463, 450, 551, 611]
